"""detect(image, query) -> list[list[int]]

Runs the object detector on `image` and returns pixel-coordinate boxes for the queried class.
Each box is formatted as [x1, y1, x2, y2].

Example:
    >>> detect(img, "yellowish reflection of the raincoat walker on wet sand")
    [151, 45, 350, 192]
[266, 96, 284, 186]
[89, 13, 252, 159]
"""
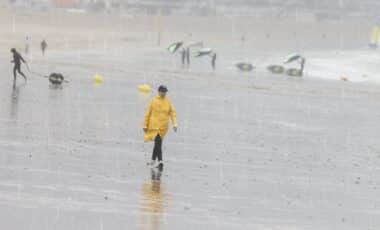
[141, 169, 166, 230]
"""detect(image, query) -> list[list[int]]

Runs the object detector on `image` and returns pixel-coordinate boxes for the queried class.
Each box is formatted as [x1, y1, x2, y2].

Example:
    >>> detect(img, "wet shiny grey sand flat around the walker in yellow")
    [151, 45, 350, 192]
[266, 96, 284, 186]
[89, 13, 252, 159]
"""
[0, 7, 380, 230]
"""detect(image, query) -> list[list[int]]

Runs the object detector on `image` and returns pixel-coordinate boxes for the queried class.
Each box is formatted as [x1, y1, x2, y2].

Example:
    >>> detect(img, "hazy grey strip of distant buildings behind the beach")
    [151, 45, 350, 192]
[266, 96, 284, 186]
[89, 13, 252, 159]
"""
[3, 0, 380, 21]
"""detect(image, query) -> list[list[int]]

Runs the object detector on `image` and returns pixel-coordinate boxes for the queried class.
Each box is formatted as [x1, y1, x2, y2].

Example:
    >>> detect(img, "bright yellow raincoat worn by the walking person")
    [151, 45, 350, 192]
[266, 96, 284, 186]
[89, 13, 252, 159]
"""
[144, 96, 177, 141]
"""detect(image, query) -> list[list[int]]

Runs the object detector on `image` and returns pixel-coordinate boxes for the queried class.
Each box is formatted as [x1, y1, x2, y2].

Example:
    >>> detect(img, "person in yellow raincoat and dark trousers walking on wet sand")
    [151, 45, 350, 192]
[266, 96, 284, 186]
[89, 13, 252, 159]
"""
[143, 85, 177, 170]
